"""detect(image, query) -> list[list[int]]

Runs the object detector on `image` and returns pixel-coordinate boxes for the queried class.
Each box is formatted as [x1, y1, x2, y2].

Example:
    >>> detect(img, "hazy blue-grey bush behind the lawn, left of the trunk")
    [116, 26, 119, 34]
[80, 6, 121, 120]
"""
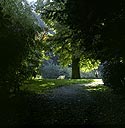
[40, 62, 71, 79]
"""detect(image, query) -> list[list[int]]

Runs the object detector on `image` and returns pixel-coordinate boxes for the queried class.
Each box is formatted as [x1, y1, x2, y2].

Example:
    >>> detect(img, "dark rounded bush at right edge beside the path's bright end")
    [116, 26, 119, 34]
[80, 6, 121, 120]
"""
[101, 60, 125, 90]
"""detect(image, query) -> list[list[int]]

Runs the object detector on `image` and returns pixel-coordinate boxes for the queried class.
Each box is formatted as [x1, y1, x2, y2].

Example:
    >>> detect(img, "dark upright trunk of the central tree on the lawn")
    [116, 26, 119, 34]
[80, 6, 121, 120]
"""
[72, 56, 80, 79]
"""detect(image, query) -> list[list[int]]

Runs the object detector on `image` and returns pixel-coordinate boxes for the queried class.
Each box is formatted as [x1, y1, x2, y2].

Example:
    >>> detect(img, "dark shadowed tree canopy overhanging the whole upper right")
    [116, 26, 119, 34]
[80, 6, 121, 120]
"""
[36, 0, 125, 87]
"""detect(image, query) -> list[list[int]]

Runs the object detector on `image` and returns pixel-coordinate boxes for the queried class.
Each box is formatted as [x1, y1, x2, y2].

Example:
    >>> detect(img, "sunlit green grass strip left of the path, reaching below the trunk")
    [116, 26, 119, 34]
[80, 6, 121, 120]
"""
[20, 79, 93, 94]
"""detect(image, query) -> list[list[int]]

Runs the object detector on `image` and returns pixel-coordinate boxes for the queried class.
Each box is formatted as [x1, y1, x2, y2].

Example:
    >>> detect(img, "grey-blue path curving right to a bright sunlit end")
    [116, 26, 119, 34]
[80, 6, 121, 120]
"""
[47, 79, 103, 101]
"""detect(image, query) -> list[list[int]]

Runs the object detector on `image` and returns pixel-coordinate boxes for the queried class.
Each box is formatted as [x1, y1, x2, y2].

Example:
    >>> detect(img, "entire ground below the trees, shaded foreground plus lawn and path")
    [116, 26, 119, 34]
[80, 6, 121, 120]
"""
[0, 79, 125, 128]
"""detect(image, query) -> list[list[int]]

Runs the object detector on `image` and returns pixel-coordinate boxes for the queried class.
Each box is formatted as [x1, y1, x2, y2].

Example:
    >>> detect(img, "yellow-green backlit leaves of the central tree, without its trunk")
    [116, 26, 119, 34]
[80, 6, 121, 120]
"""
[41, 21, 100, 74]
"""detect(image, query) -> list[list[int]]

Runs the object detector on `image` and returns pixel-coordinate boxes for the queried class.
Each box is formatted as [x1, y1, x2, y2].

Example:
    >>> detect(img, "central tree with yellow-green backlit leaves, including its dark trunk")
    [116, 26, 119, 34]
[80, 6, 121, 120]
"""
[42, 23, 99, 79]
